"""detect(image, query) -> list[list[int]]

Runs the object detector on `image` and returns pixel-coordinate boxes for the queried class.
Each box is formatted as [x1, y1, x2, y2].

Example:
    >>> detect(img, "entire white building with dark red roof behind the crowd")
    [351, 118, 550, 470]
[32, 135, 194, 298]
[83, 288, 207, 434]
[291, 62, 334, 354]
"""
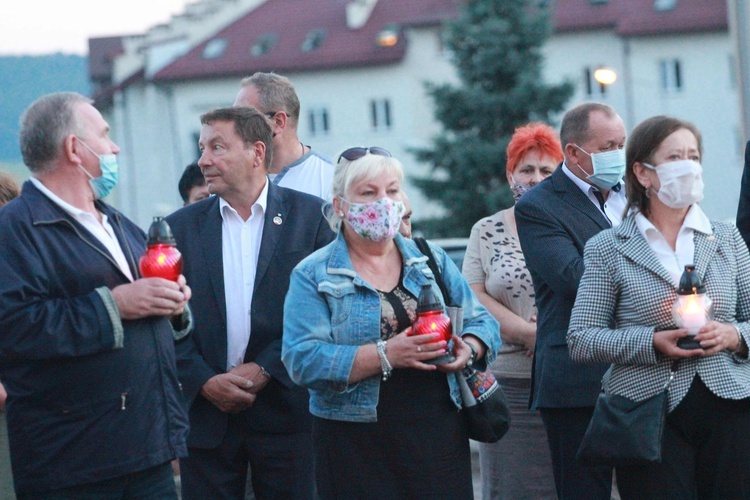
[91, 0, 744, 229]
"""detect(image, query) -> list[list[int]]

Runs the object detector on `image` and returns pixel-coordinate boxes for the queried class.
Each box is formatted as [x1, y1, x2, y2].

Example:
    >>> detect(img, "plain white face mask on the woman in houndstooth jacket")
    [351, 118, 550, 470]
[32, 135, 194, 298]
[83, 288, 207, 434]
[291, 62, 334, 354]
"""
[643, 160, 703, 208]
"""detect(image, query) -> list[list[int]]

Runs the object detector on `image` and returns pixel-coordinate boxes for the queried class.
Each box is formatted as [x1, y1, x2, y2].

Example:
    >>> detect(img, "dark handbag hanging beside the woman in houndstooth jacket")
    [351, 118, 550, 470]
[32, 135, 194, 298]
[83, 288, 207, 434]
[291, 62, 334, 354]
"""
[576, 361, 678, 467]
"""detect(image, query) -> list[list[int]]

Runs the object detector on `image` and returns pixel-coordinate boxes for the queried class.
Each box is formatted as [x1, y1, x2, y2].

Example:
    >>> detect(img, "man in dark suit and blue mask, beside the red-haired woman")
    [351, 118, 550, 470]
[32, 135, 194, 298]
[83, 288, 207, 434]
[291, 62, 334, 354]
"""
[516, 103, 627, 499]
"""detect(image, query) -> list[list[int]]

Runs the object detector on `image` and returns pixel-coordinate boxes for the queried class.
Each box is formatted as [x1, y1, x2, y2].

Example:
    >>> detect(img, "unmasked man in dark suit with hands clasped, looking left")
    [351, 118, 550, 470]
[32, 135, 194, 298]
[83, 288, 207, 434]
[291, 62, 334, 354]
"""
[167, 107, 333, 499]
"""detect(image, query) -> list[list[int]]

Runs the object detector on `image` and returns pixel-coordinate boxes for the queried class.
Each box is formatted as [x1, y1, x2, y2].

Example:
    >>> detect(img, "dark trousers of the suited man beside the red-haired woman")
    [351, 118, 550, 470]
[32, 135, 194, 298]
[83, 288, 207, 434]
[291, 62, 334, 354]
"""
[539, 406, 619, 500]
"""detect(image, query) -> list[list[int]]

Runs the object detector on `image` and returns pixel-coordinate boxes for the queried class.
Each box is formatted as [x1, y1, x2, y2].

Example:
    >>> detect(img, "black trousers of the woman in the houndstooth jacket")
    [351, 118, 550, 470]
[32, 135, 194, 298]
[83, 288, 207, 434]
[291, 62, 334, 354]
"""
[617, 375, 750, 500]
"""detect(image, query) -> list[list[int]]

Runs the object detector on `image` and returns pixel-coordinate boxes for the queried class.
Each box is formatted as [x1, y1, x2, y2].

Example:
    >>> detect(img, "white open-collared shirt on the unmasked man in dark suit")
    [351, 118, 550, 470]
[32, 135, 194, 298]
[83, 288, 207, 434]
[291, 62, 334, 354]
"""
[219, 181, 268, 370]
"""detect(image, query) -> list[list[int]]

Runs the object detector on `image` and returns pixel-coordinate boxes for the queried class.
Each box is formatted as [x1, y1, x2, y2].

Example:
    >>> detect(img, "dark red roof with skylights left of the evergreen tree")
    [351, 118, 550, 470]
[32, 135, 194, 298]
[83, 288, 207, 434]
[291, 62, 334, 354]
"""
[154, 0, 456, 81]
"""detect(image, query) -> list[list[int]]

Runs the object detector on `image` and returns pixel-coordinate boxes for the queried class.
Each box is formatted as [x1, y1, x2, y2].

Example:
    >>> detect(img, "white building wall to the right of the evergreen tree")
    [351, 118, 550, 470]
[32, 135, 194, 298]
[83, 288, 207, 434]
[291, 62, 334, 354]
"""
[544, 31, 744, 220]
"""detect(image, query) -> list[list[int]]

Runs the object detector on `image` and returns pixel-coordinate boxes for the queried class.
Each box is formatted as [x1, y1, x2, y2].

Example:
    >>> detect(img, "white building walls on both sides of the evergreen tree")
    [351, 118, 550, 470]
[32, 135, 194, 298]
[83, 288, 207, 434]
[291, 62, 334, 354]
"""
[108, 20, 744, 229]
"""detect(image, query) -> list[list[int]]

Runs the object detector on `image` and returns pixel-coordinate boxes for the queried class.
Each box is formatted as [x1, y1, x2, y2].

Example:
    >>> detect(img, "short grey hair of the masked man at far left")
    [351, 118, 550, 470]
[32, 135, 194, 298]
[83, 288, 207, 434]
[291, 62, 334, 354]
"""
[18, 92, 93, 173]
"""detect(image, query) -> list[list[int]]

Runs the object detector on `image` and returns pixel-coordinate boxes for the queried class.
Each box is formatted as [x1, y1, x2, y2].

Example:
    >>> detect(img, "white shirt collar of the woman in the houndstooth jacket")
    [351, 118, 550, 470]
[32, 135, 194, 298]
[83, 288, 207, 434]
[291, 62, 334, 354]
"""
[635, 204, 713, 288]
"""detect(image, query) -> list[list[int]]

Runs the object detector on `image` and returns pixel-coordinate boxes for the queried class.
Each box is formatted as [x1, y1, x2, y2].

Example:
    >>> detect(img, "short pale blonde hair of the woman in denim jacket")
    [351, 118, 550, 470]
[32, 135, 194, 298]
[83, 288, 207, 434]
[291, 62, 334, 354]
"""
[323, 153, 404, 232]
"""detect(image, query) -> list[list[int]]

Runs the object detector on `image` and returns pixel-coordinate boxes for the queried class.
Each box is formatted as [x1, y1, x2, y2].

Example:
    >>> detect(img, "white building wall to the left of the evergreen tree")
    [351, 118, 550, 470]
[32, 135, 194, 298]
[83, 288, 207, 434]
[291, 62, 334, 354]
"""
[108, 28, 456, 228]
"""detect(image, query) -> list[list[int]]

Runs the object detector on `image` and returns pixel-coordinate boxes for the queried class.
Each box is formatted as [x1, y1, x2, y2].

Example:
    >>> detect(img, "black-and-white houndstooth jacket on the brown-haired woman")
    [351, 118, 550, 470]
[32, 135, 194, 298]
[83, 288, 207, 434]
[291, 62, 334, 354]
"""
[567, 216, 750, 411]
